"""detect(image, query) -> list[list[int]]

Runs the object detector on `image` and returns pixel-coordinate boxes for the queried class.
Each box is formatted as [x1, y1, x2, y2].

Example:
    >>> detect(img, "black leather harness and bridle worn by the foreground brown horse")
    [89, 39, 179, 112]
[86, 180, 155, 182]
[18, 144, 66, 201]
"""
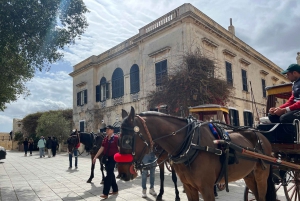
[121, 115, 265, 192]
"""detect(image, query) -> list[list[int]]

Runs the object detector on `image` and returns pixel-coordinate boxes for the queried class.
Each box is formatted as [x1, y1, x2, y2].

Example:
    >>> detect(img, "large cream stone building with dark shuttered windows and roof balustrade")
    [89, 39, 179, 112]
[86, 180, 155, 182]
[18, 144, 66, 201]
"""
[70, 4, 288, 132]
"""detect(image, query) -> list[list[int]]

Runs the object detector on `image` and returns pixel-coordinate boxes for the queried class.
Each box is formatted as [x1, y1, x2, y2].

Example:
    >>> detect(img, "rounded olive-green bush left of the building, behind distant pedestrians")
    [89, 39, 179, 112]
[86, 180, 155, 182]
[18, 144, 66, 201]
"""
[36, 111, 71, 141]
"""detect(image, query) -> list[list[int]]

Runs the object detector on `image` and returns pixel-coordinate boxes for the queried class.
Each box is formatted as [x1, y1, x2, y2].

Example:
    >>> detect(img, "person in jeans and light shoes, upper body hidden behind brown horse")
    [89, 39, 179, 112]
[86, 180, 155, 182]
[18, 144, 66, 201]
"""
[142, 152, 157, 198]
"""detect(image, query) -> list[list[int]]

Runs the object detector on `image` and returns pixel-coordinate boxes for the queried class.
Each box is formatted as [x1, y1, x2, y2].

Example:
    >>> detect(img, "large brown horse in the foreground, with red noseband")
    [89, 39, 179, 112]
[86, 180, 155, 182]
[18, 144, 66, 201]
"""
[118, 107, 276, 201]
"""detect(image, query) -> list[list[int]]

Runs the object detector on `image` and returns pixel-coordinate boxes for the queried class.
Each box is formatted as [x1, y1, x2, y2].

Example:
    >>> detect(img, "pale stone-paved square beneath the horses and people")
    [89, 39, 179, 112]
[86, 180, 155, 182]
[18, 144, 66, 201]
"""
[0, 151, 285, 201]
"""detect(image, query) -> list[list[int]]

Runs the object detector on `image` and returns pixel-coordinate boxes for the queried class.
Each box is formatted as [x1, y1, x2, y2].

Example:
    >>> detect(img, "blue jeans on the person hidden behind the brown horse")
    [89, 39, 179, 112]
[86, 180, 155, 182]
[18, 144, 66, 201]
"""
[142, 152, 156, 189]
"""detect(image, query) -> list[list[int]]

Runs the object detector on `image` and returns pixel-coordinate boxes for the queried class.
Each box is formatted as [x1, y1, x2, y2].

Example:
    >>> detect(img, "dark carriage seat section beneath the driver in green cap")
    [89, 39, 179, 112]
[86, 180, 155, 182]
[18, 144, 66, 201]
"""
[257, 123, 297, 144]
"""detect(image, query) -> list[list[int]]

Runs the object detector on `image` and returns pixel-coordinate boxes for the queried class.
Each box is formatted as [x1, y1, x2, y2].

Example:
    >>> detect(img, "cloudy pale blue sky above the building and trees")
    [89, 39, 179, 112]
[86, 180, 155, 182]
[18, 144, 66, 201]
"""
[0, 0, 300, 132]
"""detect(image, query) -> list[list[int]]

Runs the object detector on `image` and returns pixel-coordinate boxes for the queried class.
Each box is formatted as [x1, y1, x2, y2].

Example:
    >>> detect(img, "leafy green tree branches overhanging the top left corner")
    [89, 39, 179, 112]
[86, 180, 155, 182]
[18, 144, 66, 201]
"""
[0, 0, 88, 111]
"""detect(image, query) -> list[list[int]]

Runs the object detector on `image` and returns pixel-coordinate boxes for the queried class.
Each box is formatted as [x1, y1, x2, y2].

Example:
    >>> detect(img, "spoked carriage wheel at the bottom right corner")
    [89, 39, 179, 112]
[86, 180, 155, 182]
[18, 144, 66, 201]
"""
[283, 171, 300, 201]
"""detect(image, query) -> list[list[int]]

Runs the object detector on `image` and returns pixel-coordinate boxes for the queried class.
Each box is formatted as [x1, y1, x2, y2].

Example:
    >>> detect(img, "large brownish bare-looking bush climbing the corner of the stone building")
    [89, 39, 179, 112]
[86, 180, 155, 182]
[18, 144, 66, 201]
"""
[148, 50, 233, 116]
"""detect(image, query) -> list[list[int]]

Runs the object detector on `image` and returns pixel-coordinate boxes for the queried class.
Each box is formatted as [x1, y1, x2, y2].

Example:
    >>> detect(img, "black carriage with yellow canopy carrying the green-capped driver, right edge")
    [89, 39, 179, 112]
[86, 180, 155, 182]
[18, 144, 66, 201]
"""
[244, 83, 300, 201]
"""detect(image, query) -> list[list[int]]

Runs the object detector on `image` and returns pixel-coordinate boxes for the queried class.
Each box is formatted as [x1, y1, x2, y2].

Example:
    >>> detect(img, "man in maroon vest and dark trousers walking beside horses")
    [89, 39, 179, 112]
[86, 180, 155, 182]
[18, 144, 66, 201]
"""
[93, 125, 119, 199]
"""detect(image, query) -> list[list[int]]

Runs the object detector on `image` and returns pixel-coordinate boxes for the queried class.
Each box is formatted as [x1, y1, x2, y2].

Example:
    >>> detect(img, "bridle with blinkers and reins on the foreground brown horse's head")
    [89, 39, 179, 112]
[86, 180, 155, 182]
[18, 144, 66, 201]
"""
[121, 115, 192, 169]
